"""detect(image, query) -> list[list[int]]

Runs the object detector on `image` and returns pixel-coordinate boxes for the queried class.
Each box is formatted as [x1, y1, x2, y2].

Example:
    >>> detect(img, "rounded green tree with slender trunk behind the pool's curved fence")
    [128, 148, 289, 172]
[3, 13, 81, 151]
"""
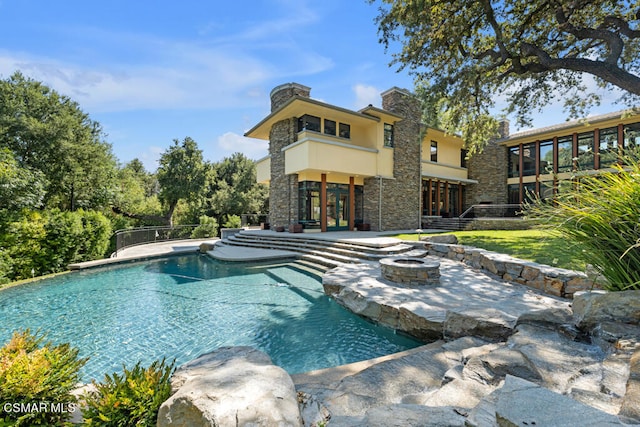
[157, 137, 209, 225]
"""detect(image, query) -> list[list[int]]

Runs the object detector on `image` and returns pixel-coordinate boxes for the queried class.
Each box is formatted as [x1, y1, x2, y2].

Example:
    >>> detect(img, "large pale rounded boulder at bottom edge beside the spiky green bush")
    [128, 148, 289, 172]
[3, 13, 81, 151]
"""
[158, 347, 302, 427]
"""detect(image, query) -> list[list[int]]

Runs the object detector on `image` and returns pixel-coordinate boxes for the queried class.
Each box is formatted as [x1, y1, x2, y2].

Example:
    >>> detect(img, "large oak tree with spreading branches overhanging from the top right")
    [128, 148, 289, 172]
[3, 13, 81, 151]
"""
[369, 0, 640, 153]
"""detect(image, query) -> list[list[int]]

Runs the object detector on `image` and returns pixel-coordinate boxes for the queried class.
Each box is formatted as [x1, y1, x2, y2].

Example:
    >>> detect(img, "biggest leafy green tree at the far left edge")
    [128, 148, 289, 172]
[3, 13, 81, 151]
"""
[0, 72, 116, 210]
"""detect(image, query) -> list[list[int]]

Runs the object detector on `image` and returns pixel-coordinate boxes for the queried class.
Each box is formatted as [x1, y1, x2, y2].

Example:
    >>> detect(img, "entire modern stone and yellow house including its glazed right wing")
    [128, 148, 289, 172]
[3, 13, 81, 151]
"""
[245, 83, 640, 231]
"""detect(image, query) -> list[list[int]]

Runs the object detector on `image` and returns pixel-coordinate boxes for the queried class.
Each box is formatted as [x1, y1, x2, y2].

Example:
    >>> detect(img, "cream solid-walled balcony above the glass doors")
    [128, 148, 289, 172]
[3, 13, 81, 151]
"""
[283, 137, 378, 177]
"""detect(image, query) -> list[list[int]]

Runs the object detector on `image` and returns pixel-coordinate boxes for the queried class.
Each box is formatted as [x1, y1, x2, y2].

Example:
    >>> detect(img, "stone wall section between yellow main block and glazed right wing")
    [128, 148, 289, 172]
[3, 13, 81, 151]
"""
[464, 120, 509, 207]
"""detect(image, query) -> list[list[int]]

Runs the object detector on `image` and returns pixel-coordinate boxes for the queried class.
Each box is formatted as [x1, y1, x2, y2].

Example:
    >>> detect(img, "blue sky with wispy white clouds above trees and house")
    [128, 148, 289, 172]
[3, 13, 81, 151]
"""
[0, 0, 614, 170]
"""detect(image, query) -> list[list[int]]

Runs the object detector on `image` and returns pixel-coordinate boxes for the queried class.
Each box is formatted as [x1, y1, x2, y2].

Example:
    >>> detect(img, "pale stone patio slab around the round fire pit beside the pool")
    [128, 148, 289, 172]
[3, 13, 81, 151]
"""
[322, 256, 570, 342]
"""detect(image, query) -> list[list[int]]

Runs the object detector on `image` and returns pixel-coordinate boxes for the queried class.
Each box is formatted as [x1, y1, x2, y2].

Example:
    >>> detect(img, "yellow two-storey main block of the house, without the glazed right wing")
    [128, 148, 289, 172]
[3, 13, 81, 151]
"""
[245, 83, 475, 231]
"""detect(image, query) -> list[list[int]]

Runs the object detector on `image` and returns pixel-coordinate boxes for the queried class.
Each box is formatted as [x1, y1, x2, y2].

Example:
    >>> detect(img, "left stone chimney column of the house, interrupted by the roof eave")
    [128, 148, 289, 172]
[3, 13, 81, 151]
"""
[269, 83, 311, 228]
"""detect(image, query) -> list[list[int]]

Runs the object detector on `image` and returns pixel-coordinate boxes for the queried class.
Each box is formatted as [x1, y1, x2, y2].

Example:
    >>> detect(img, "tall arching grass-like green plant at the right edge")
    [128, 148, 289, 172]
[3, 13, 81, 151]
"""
[525, 159, 640, 291]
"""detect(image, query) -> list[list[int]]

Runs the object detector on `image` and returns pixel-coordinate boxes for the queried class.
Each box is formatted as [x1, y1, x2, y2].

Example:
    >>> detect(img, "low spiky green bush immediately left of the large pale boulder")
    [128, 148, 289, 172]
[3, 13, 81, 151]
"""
[83, 359, 175, 427]
